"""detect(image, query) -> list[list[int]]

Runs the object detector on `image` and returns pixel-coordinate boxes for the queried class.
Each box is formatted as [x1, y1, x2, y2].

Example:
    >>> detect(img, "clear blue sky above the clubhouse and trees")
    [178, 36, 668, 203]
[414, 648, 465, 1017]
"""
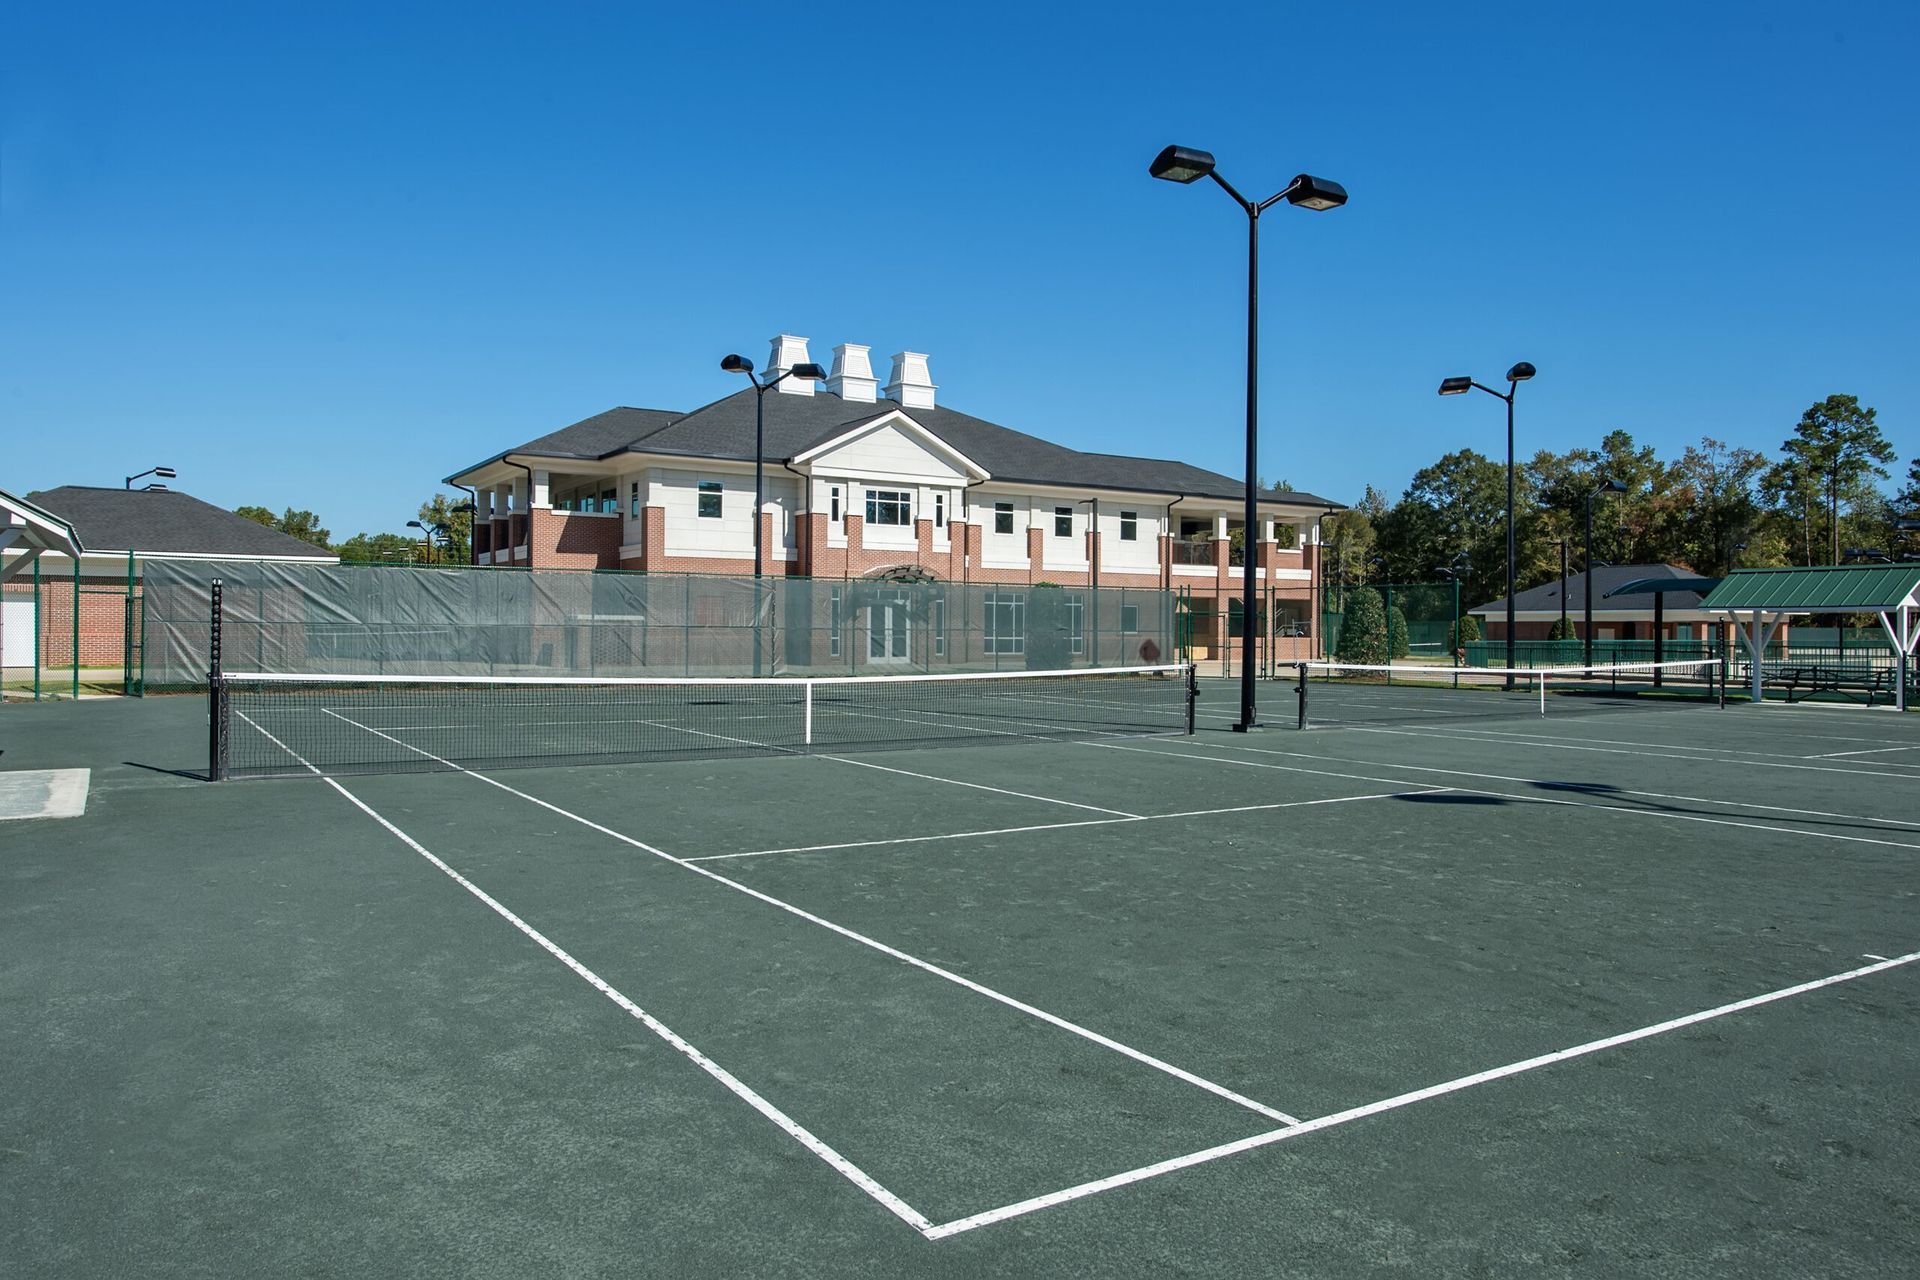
[0, 2, 1920, 537]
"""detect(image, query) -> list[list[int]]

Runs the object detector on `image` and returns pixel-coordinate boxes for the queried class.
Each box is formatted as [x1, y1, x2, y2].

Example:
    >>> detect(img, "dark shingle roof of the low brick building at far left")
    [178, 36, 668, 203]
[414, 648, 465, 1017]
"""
[27, 484, 330, 557]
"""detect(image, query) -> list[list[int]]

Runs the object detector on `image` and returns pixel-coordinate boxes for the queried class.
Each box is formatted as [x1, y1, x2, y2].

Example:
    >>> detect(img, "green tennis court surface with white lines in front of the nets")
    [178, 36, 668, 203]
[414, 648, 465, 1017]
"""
[0, 681, 1920, 1276]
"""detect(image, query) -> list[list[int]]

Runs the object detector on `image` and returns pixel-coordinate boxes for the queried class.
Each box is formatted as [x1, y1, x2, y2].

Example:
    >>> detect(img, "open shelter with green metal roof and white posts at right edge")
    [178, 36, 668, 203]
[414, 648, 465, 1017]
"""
[1699, 564, 1920, 710]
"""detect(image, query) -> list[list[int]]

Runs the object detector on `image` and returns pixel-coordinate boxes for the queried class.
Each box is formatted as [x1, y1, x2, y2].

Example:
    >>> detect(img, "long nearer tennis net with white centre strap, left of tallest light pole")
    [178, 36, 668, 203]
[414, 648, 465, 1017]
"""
[209, 666, 1192, 777]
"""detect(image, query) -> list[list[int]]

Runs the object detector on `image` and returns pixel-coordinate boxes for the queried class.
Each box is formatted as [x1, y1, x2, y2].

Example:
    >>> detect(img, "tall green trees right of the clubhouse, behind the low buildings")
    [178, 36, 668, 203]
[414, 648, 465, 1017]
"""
[1323, 395, 1920, 604]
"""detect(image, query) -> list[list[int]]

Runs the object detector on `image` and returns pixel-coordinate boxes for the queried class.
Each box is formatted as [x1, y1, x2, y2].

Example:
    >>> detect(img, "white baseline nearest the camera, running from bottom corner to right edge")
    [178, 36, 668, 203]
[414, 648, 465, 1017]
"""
[922, 952, 1920, 1240]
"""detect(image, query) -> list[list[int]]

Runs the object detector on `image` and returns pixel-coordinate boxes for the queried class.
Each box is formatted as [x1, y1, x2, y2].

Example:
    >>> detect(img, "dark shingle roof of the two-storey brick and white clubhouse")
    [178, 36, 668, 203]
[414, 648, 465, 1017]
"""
[464, 388, 1340, 510]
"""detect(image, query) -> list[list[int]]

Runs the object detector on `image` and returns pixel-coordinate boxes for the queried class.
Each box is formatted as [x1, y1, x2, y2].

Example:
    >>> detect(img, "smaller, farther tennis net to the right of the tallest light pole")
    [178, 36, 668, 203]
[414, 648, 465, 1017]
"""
[1298, 658, 1724, 729]
